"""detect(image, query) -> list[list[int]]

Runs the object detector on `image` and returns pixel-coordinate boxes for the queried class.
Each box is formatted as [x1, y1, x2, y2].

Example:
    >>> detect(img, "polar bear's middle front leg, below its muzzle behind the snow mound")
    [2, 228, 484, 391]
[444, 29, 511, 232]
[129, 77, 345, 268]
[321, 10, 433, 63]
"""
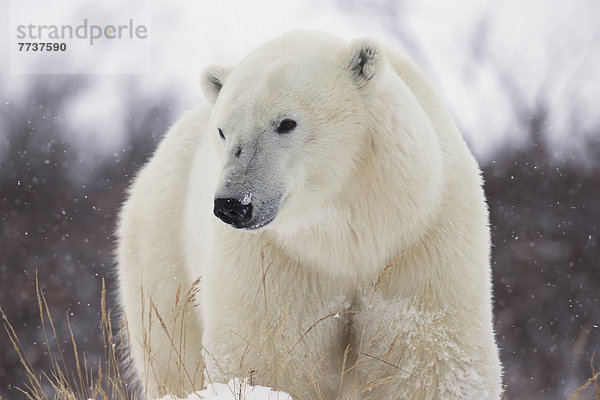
[201, 241, 351, 399]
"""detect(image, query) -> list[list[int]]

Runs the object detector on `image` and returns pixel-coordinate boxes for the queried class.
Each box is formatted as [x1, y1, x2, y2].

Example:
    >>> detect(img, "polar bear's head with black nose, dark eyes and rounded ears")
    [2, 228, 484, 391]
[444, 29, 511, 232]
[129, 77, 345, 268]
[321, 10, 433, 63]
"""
[201, 31, 438, 231]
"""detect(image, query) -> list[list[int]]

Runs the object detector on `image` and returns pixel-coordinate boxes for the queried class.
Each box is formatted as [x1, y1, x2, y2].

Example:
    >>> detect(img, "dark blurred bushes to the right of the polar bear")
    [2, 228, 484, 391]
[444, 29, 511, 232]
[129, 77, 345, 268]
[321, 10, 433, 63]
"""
[483, 127, 600, 399]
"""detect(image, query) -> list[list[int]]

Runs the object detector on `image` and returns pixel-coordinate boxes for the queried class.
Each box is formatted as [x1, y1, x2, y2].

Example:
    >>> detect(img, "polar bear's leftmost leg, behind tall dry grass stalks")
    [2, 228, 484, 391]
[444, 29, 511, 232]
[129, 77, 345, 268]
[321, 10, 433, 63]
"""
[119, 236, 203, 398]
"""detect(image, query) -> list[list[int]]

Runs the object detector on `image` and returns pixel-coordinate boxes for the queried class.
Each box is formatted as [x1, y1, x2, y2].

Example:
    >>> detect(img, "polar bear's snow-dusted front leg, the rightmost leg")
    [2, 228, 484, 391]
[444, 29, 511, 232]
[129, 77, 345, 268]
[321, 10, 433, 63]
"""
[346, 294, 500, 400]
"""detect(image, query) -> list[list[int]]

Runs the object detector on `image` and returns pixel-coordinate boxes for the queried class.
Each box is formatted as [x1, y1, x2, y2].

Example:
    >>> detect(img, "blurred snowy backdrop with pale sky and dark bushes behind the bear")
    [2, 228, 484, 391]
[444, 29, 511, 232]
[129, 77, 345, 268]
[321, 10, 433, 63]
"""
[0, 0, 600, 399]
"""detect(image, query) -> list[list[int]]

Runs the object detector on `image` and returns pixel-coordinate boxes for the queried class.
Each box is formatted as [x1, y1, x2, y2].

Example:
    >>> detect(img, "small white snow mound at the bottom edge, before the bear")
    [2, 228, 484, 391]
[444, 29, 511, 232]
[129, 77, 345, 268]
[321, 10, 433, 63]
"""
[157, 379, 292, 400]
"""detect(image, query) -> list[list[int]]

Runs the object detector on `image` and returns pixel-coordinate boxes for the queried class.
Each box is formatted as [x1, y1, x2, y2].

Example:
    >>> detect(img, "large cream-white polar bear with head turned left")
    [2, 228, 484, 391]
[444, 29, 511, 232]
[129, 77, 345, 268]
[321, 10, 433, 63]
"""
[118, 31, 501, 400]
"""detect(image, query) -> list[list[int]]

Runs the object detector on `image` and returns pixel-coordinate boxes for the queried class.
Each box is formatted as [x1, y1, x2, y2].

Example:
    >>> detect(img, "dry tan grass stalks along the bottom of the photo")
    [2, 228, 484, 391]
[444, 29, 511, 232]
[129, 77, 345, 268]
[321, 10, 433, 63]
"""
[0, 262, 600, 400]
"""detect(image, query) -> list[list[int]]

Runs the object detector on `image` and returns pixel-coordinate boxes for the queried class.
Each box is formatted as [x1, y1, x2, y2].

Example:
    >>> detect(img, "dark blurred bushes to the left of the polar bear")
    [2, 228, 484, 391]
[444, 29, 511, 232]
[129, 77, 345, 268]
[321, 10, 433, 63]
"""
[0, 76, 174, 399]
